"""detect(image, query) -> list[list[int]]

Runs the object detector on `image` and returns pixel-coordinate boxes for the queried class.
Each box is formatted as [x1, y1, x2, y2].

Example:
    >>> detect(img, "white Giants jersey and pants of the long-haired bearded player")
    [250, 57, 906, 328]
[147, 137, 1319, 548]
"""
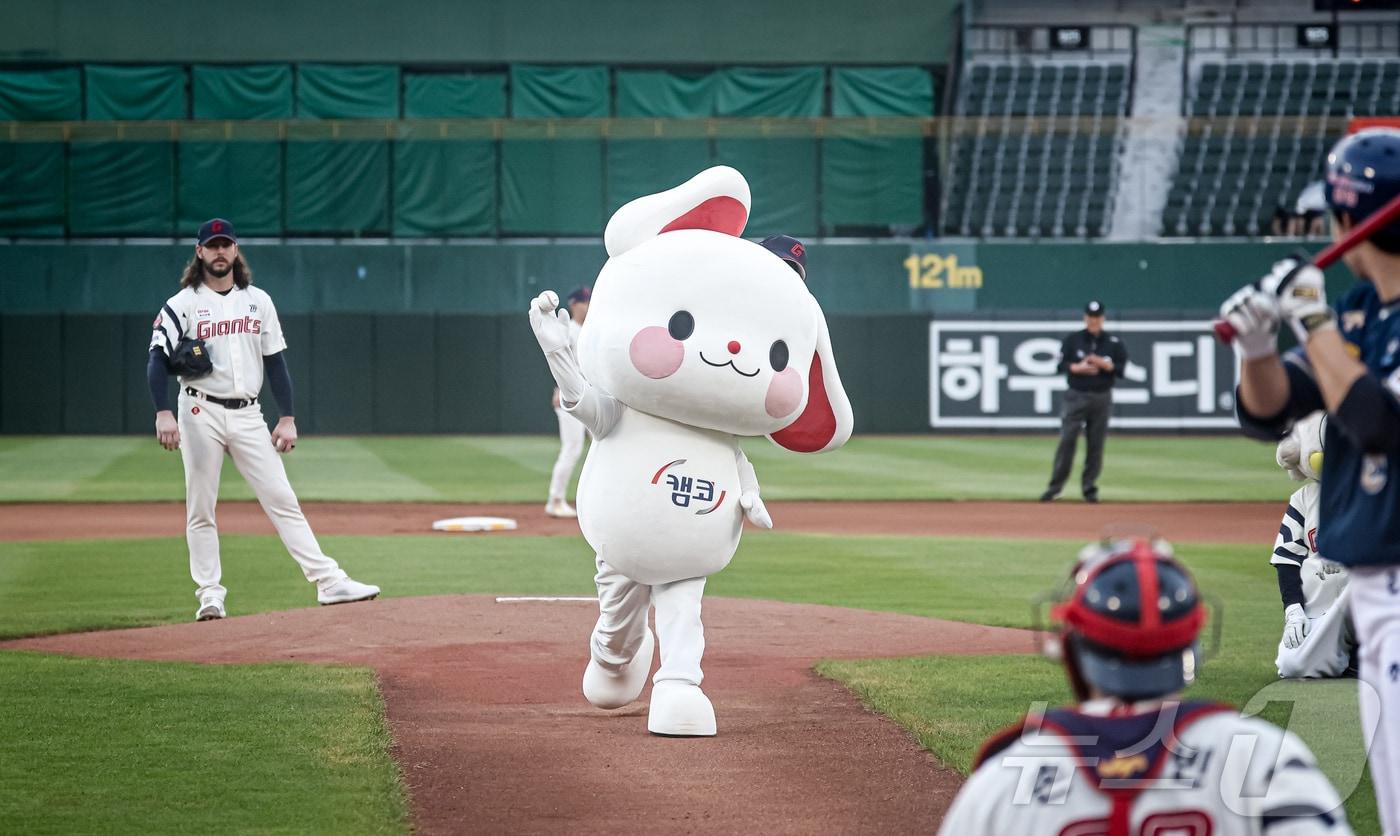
[151, 284, 346, 602]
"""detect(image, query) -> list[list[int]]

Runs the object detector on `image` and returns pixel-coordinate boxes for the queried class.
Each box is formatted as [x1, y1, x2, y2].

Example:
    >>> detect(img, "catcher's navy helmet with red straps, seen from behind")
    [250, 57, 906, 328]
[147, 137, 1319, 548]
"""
[1051, 539, 1205, 702]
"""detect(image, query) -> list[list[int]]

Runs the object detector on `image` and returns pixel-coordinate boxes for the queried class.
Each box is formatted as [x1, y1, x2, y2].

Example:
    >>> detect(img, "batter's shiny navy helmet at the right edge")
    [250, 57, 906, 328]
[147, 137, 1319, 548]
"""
[1326, 127, 1400, 238]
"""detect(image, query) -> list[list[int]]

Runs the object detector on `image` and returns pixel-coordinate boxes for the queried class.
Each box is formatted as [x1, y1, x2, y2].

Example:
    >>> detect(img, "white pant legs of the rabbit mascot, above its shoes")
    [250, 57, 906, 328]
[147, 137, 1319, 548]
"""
[589, 556, 706, 686]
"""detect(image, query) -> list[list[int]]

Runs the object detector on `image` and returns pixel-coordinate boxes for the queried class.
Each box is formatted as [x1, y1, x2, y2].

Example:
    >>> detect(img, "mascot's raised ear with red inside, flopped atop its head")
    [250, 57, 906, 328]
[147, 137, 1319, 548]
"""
[603, 165, 752, 256]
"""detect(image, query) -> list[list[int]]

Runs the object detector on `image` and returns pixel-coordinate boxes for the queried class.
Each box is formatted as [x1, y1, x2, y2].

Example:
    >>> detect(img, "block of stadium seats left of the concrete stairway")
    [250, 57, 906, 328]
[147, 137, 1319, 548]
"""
[941, 62, 1131, 238]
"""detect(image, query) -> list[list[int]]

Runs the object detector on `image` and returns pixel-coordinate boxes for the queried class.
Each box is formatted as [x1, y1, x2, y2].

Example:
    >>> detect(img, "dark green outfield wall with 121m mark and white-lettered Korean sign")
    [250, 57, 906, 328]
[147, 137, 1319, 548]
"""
[0, 242, 1348, 434]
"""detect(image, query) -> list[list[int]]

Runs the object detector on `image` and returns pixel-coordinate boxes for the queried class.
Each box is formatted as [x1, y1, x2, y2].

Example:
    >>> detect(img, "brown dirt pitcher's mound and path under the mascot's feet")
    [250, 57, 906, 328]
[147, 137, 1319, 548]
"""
[0, 596, 1030, 836]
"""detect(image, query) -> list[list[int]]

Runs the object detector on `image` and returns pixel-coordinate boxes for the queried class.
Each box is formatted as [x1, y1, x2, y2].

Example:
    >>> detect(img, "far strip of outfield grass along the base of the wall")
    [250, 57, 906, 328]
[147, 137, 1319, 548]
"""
[0, 436, 1291, 503]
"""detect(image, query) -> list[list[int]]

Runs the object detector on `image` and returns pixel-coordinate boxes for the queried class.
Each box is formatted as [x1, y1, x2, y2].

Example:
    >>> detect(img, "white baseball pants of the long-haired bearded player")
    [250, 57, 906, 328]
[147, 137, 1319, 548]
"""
[179, 393, 346, 601]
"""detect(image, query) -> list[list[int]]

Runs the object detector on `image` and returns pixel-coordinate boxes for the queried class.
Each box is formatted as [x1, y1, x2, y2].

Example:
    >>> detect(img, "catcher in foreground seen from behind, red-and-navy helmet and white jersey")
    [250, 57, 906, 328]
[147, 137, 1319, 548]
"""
[939, 539, 1351, 836]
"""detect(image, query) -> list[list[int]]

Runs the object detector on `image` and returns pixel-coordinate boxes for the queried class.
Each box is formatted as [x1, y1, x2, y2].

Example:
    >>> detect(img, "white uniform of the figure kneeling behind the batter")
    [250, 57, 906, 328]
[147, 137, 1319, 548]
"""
[1268, 482, 1357, 678]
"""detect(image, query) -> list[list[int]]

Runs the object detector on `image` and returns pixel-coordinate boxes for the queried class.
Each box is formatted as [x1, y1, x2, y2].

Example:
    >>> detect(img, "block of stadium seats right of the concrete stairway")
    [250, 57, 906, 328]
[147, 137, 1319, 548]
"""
[1162, 60, 1400, 235]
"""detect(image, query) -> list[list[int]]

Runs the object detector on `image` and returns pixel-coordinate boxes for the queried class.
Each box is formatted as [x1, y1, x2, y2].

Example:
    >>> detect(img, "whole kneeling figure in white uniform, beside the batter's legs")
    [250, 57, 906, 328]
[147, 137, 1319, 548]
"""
[1268, 412, 1357, 678]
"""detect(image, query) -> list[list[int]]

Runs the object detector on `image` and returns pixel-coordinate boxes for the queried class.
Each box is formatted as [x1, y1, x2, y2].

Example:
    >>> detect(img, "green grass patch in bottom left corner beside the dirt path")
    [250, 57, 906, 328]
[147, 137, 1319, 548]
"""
[0, 653, 407, 835]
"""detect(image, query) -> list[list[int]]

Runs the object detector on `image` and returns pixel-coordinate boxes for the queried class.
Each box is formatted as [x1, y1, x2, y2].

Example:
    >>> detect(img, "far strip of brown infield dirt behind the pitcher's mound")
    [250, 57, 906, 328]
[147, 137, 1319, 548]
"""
[0, 501, 1282, 543]
